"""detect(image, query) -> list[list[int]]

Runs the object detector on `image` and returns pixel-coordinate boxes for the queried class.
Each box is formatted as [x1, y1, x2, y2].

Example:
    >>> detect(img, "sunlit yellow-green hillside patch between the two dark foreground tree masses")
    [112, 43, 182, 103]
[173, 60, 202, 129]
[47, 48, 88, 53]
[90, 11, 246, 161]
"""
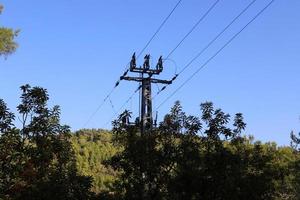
[71, 129, 120, 194]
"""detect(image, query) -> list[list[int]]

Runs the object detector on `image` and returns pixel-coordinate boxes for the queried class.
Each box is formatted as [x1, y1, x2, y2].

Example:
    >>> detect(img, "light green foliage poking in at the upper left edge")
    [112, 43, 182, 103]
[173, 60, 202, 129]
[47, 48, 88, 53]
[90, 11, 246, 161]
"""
[0, 4, 19, 57]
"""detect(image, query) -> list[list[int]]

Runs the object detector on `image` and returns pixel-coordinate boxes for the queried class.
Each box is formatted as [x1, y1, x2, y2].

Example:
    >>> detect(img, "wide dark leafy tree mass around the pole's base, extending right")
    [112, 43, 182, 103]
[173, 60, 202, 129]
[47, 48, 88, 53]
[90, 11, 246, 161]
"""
[107, 102, 293, 200]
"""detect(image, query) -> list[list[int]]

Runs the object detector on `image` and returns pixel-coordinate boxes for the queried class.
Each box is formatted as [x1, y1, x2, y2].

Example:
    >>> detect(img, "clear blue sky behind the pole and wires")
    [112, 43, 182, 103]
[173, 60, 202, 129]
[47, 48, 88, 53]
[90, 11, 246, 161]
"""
[0, 0, 300, 145]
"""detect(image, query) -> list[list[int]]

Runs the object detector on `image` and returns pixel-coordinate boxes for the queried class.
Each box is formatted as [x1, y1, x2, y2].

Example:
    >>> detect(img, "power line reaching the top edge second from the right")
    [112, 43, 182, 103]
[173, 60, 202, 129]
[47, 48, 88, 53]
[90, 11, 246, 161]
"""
[153, 0, 257, 98]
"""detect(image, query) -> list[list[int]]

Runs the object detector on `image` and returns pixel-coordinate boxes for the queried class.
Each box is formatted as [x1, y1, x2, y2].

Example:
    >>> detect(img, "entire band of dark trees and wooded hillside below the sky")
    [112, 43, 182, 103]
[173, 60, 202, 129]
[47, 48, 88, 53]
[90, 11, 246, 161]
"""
[0, 85, 300, 200]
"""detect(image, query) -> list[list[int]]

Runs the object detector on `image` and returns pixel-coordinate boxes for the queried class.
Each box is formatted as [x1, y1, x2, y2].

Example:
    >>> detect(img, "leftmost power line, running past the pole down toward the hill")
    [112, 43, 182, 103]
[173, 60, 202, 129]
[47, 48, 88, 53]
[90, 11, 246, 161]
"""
[83, 0, 182, 127]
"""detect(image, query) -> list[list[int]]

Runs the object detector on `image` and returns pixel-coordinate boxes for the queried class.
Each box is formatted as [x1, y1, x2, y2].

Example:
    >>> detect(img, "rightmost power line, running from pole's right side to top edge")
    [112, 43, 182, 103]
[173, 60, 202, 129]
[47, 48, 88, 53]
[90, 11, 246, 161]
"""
[156, 0, 275, 109]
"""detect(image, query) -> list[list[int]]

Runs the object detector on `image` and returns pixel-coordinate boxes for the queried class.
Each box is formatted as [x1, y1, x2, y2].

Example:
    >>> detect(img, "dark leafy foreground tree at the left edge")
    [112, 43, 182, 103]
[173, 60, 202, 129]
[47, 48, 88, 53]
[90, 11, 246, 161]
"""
[0, 85, 92, 199]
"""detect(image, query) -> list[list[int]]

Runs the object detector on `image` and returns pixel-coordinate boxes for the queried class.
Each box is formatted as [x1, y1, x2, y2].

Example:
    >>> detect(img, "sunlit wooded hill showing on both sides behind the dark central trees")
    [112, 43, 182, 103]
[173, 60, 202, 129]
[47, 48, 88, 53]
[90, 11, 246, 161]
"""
[71, 129, 300, 200]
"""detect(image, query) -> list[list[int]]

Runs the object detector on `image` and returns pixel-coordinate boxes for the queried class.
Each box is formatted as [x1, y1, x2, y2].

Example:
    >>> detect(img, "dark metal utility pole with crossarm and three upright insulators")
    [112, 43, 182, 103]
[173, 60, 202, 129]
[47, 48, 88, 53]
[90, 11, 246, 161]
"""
[120, 53, 172, 134]
